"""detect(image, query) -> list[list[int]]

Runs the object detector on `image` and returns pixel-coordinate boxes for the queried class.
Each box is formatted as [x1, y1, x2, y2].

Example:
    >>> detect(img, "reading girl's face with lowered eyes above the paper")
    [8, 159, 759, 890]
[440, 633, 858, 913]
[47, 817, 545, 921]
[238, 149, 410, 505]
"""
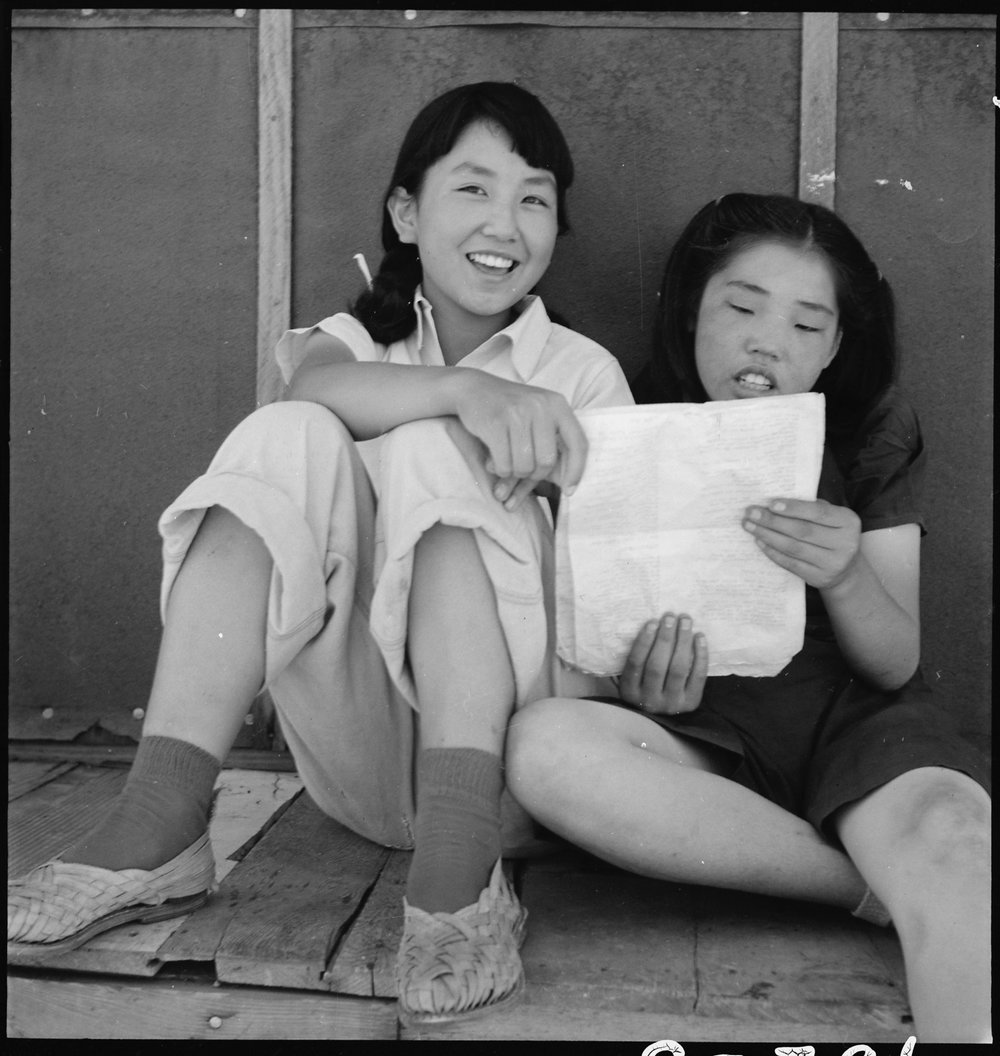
[695, 242, 841, 399]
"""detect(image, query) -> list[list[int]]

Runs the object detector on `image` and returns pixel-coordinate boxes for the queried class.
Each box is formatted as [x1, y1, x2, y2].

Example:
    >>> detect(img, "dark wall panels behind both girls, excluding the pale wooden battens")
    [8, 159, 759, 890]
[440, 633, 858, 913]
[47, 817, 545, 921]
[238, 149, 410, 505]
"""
[10, 12, 995, 738]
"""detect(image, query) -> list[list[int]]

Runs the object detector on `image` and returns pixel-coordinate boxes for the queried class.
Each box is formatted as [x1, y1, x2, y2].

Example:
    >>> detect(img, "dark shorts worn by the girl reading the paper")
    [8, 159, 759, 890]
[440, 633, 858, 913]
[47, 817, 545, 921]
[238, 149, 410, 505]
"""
[595, 639, 989, 841]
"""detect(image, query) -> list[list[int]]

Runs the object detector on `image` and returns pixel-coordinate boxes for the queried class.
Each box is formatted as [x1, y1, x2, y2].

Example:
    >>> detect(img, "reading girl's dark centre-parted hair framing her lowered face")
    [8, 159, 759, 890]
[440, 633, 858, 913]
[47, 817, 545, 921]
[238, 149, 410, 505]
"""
[642, 194, 897, 428]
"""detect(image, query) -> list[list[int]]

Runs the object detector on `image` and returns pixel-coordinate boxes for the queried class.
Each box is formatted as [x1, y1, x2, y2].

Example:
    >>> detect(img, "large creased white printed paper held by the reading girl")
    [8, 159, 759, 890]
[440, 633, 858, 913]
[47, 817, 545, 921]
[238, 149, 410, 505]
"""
[555, 393, 825, 676]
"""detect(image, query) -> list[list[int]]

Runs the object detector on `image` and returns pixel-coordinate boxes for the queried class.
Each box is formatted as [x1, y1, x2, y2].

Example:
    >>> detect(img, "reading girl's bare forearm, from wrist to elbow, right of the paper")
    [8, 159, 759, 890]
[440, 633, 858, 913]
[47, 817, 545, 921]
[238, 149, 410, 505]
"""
[819, 554, 920, 690]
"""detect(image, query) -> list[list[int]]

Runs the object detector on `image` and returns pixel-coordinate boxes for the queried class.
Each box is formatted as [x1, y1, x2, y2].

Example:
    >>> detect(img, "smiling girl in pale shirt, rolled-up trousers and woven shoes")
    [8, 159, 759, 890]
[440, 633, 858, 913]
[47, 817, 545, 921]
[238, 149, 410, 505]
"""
[7, 82, 631, 1019]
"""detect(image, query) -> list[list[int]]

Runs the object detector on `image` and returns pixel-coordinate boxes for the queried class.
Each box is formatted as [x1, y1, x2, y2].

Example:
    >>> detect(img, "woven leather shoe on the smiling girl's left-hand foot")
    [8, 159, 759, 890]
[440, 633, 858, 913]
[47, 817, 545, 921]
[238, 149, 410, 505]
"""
[7, 832, 216, 956]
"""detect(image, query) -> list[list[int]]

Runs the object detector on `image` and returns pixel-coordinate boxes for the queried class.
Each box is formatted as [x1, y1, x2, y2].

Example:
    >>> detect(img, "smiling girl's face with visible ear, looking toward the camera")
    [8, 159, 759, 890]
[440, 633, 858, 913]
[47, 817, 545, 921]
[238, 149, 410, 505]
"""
[390, 121, 558, 337]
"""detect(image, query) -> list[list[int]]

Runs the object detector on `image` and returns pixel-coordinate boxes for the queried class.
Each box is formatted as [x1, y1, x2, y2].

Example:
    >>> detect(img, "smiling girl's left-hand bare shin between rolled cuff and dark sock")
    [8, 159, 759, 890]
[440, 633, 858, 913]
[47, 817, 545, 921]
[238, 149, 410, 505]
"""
[143, 507, 271, 761]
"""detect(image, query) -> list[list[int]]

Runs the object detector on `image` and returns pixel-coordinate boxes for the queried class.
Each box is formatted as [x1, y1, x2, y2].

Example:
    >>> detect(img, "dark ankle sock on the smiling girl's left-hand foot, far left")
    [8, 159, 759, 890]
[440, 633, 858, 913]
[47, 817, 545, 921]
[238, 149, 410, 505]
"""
[59, 737, 222, 870]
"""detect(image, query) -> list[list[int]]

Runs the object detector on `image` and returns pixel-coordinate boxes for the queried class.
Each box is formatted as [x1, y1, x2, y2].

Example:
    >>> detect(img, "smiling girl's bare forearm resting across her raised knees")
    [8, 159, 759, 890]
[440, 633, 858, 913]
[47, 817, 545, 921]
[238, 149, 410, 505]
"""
[287, 362, 476, 440]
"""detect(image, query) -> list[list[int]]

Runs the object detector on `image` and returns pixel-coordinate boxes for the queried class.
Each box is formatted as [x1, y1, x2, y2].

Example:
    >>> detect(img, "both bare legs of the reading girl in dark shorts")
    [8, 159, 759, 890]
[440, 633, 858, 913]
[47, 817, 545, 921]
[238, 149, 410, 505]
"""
[507, 700, 990, 1042]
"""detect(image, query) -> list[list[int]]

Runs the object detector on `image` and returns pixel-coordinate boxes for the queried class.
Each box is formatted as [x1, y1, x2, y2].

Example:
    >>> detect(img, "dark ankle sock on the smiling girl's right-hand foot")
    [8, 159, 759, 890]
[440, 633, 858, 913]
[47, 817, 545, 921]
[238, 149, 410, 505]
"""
[407, 748, 504, 913]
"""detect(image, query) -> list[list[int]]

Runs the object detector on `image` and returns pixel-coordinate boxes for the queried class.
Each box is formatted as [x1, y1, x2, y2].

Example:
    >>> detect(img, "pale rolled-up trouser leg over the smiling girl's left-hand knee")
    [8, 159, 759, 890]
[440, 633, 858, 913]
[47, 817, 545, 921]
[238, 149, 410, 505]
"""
[159, 401, 414, 847]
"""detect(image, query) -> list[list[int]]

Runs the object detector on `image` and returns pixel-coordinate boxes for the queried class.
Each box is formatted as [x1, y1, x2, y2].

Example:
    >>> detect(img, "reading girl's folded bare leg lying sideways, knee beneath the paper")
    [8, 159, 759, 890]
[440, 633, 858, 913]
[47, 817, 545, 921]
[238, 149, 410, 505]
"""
[507, 700, 866, 909]
